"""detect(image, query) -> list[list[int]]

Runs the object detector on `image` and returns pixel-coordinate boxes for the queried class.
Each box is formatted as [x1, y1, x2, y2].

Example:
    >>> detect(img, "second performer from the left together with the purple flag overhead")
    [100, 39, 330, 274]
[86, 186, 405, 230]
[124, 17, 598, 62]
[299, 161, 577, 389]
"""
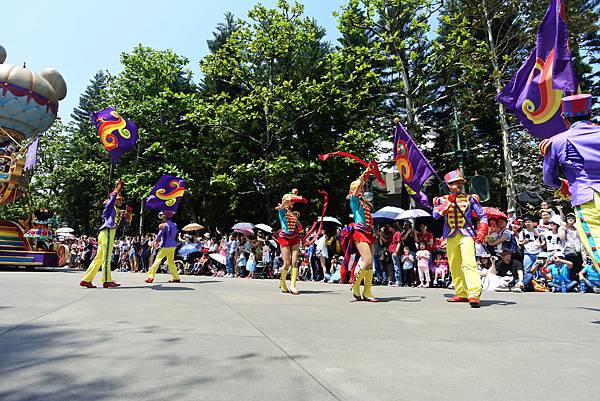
[146, 174, 186, 284]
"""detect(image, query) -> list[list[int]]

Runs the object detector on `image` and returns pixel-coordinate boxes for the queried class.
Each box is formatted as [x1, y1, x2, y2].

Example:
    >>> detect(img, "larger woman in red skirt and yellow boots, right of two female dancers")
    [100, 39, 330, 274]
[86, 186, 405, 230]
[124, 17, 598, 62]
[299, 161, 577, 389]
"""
[340, 165, 378, 302]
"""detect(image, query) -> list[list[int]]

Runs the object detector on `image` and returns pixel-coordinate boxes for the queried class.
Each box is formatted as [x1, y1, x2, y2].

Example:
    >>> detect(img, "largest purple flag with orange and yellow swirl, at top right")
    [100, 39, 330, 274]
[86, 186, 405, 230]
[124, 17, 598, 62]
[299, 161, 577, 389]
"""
[497, 0, 578, 138]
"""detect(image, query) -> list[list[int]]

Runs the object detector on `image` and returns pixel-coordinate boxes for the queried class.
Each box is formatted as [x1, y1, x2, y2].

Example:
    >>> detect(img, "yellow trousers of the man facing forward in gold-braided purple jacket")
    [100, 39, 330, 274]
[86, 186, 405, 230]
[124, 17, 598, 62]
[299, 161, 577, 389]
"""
[446, 234, 481, 299]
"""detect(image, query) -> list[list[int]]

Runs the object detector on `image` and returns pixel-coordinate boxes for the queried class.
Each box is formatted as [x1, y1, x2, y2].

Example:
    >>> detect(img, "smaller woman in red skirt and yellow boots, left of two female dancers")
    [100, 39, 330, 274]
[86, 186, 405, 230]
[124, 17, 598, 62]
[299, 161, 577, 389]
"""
[275, 189, 308, 295]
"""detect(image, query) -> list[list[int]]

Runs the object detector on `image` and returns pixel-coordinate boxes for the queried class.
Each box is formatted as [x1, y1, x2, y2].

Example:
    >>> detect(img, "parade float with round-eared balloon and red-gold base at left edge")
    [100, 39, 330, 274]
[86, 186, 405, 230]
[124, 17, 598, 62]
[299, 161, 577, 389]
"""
[0, 46, 67, 266]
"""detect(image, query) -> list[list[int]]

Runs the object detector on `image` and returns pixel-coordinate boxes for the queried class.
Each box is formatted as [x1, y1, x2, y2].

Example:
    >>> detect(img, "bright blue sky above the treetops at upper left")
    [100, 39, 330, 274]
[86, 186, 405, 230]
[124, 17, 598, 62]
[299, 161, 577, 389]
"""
[0, 0, 346, 120]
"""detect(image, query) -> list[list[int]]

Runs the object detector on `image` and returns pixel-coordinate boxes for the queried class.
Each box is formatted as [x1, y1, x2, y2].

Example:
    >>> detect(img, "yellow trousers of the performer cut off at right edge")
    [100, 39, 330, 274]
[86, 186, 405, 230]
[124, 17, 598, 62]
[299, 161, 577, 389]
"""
[575, 192, 600, 272]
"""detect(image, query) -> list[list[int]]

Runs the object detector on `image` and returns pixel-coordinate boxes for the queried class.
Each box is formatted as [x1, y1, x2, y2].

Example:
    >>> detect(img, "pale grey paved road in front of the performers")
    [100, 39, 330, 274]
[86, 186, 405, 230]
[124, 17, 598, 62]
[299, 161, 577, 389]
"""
[0, 272, 600, 401]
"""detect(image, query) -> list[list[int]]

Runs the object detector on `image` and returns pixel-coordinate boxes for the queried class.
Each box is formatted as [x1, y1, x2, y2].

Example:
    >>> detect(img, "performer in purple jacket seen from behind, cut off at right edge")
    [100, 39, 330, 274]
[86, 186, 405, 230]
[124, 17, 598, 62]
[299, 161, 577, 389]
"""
[540, 94, 600, 271]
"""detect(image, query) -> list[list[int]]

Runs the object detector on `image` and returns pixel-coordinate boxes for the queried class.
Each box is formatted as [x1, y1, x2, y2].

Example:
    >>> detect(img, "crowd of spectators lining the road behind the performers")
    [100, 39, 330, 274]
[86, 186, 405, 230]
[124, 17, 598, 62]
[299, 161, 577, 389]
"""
[55, 198, 600, 293]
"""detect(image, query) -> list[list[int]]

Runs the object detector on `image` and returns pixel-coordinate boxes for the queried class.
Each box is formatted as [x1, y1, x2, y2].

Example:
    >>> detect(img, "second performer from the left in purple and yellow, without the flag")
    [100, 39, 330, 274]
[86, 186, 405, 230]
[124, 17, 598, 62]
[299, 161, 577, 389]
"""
[145, 210, 181, 284]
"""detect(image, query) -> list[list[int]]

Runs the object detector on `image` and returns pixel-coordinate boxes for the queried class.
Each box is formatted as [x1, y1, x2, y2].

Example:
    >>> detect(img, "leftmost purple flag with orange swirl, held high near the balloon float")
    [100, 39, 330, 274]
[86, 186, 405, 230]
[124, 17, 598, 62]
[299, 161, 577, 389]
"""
[92, 107, 138, 164]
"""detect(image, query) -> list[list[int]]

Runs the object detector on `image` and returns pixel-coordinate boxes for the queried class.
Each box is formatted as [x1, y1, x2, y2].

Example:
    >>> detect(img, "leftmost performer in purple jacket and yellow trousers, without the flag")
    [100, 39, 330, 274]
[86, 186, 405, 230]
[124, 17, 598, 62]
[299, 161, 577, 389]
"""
[79, 179, 131, 288]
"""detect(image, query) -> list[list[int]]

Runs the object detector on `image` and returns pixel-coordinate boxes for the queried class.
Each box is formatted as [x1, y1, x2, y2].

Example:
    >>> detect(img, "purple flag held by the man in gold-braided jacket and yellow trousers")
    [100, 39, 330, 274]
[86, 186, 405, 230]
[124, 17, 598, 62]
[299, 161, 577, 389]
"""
[394, 123, 435, 207]
